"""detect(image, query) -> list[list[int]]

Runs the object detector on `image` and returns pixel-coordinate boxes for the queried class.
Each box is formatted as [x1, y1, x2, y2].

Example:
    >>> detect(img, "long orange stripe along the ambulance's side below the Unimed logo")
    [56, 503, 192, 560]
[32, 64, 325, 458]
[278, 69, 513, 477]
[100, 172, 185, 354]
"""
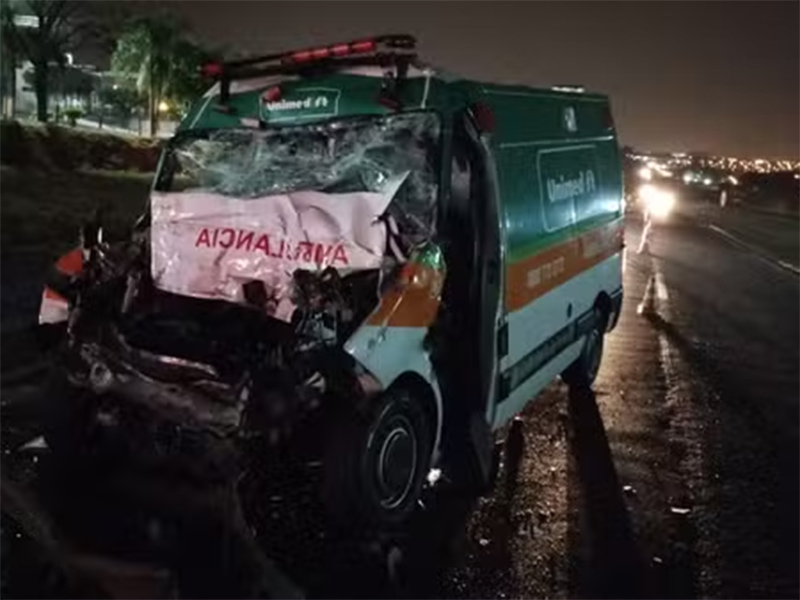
[506, 219, 623, 311]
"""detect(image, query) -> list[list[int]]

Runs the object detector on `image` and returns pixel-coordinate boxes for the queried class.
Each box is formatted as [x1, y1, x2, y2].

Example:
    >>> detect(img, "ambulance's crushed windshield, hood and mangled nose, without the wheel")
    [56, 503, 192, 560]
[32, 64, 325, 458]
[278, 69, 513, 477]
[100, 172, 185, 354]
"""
[37, 114, 445, 532]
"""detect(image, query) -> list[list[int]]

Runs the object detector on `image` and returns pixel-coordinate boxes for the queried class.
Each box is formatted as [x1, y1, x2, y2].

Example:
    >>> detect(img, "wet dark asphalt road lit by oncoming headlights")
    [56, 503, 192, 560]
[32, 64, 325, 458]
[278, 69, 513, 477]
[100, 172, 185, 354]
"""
[3, 213, 800, 598]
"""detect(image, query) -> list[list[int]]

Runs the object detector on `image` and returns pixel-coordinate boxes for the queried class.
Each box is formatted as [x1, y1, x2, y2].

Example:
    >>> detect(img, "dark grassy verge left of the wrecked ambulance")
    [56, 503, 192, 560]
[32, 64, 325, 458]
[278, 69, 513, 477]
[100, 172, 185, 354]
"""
[0, 166, 152, 346]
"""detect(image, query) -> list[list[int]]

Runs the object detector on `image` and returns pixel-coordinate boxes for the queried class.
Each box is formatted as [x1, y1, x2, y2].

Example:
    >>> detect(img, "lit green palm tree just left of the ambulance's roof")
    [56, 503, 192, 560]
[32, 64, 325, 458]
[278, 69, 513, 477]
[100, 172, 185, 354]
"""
[111, 16, 216, 136]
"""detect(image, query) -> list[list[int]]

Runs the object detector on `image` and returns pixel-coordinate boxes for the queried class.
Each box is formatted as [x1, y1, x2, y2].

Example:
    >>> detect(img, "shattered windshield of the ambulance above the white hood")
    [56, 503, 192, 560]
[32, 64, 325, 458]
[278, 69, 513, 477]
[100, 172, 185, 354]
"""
[156, 112, 441, 241]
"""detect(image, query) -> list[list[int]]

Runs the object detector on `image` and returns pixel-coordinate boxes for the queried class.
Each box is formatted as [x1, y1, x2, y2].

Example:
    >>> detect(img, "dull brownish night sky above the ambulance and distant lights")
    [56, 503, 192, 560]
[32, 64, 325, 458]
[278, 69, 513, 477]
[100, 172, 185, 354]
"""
[92, 0, 800, 159]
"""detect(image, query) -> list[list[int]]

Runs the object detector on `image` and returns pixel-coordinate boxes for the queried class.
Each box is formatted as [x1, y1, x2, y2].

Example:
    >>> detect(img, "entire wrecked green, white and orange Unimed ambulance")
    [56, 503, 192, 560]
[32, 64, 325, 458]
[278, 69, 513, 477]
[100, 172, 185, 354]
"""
[40, 35, 624, 526]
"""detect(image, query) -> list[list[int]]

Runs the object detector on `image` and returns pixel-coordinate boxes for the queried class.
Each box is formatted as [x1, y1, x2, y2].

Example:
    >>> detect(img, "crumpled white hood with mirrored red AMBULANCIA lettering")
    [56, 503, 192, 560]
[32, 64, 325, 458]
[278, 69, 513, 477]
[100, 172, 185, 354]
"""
[151, 175, 405, 321]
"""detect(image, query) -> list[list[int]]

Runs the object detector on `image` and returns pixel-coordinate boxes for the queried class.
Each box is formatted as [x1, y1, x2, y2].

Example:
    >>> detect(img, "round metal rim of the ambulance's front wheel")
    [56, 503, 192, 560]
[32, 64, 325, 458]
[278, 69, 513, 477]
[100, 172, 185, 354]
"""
[375, 415, 418, 509]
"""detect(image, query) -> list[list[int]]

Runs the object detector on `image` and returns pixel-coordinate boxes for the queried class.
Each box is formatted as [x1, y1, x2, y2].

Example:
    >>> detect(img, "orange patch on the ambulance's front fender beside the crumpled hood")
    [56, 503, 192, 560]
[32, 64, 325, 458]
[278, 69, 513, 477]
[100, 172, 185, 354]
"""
[367, 263, 444, 327]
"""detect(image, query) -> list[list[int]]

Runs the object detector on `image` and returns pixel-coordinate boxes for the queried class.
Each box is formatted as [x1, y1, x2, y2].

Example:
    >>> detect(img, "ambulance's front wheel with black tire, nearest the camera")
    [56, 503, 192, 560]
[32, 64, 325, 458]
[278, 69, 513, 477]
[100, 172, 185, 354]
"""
[322, 386, 434, 528]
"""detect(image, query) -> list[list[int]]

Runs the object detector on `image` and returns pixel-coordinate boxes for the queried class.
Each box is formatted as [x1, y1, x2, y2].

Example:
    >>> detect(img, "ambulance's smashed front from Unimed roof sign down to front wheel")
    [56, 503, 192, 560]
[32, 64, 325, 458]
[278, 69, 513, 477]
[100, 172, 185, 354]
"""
[40, 47, 446, 523]
